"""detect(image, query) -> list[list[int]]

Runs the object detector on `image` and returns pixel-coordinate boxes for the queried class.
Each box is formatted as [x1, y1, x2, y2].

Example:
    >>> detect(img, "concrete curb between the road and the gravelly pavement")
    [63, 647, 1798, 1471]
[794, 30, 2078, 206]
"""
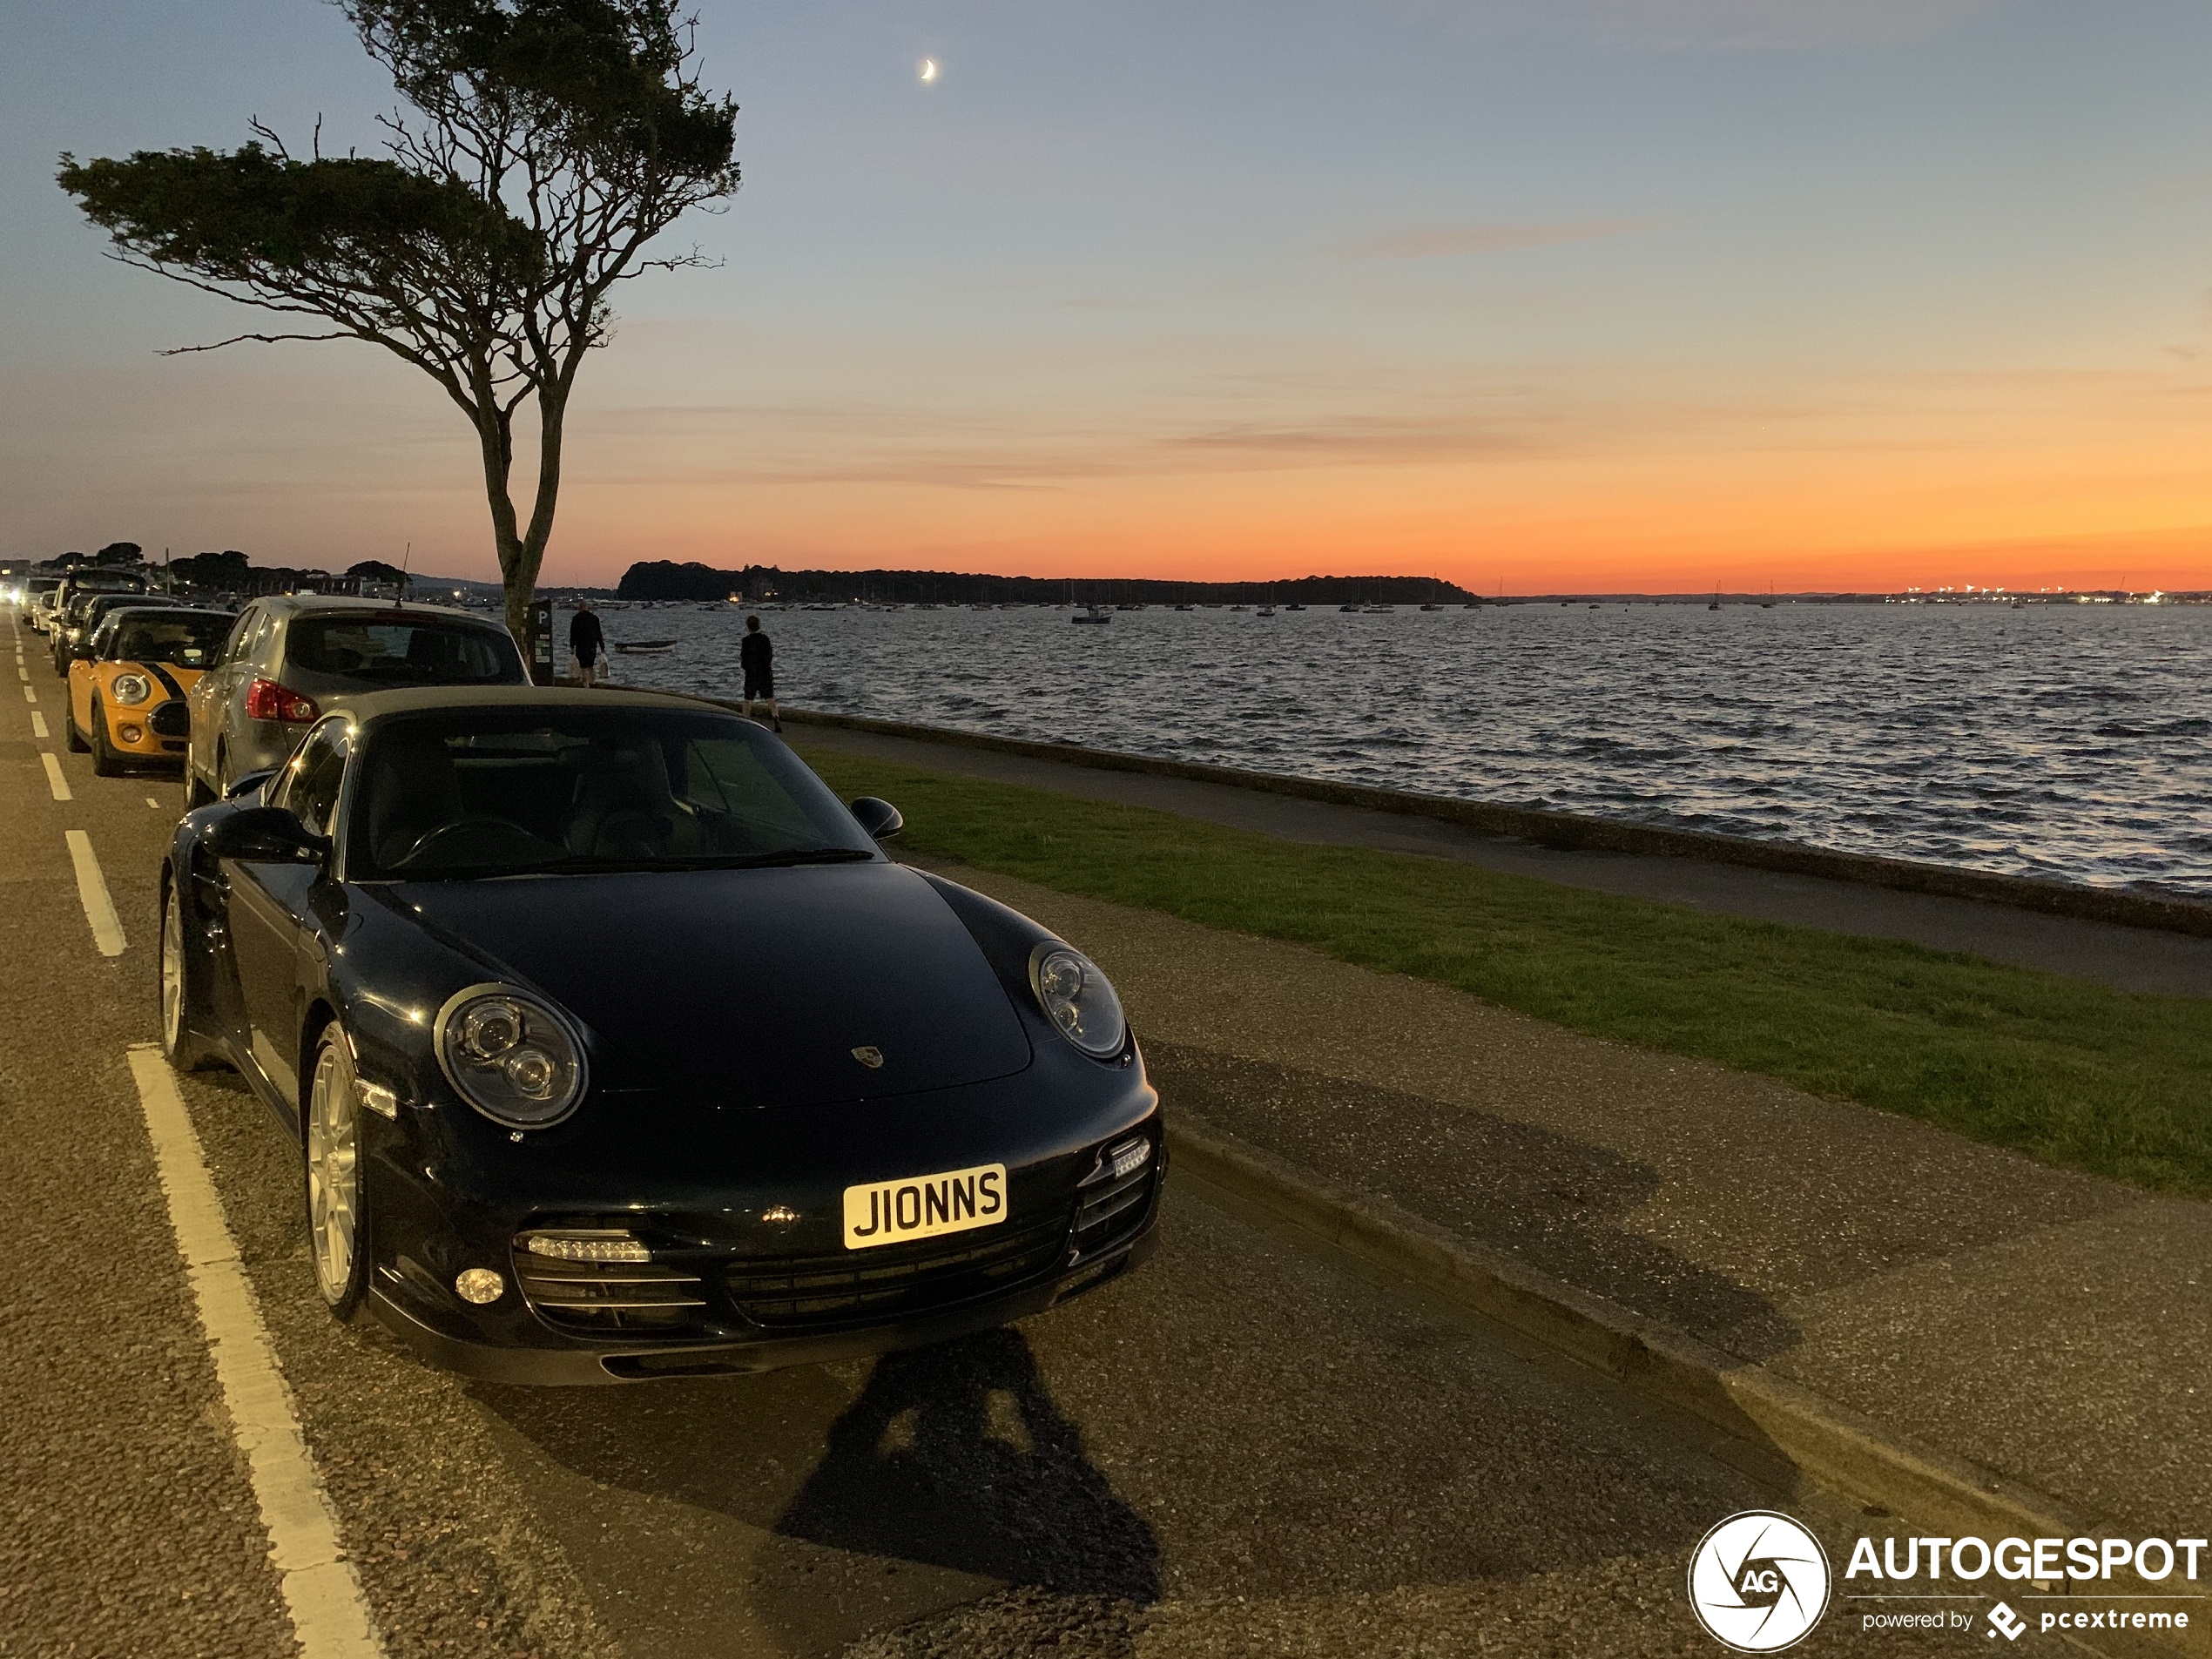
[1168, 1110, 2117, 1541]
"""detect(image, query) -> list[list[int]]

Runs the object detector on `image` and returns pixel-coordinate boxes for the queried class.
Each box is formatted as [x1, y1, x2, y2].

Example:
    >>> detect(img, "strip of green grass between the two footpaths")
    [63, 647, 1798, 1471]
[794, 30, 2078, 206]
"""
[800, 738, 2212, 1195]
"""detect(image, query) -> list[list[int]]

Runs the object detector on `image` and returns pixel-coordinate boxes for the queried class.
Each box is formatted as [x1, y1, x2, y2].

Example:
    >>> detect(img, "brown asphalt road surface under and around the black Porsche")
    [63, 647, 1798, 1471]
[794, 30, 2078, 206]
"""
[0, 613, 2026, 1659]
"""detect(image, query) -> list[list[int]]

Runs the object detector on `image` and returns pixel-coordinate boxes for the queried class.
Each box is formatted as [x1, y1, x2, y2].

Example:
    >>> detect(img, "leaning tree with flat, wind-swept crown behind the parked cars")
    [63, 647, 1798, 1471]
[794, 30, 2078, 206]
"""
[60, 0, 737, 668]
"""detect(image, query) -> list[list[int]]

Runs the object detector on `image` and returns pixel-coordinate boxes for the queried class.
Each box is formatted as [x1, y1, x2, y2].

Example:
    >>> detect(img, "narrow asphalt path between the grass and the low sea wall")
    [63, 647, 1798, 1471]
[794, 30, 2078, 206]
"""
[792, 724, 2212, 995]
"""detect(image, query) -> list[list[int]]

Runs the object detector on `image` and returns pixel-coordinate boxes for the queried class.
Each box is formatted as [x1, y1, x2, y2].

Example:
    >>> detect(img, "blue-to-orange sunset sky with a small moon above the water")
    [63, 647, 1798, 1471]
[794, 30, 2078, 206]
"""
[0, 0, 2212, 593]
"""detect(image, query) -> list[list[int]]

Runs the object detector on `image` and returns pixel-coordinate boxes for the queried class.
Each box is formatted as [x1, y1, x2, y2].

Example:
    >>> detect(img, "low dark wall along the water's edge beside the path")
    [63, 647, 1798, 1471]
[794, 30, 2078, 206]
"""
[779, 699, 2212, 938]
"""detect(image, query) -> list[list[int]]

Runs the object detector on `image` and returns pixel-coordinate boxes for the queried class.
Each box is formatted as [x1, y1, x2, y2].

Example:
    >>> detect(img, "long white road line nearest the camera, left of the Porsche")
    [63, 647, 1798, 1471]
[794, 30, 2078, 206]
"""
[128, 1042, 381, 1659]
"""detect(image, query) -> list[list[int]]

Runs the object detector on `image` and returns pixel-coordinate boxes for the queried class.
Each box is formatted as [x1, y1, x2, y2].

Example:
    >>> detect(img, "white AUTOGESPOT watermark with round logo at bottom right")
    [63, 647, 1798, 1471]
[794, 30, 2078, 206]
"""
[1690, 1508, 2212, 1652]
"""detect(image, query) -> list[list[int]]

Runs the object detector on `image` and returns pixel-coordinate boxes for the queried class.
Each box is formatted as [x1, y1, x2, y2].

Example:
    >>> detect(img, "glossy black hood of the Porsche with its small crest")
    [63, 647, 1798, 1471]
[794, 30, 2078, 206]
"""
[381, 863, 1031, 1109]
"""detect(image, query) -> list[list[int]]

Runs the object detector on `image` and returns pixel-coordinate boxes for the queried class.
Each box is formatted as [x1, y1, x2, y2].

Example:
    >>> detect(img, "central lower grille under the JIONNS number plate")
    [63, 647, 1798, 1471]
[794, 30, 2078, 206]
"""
[724, 1210, 1069, 1330]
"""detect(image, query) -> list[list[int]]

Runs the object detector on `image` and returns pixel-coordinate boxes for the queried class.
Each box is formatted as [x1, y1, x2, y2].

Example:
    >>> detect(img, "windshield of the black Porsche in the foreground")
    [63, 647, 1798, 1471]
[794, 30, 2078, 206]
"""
[347, 705, 876, 880]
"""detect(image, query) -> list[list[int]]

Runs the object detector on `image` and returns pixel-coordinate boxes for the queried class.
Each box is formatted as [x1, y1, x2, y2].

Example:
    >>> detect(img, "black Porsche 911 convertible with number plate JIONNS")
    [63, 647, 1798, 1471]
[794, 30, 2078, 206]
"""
[161, 688, 1166, 1383]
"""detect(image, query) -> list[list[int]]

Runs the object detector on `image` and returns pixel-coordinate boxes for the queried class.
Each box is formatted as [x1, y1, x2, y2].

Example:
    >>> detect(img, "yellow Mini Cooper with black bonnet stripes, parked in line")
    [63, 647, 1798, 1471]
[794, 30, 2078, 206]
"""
[64, 606, 237, 779]
